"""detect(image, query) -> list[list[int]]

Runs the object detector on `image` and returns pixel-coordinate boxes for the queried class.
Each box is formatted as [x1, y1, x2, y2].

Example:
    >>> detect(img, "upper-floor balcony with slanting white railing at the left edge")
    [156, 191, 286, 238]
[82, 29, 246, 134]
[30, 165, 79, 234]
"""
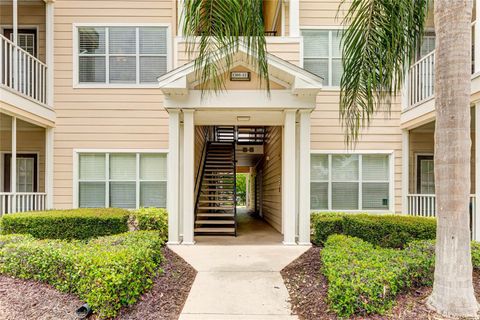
[0, 0, 55, 124]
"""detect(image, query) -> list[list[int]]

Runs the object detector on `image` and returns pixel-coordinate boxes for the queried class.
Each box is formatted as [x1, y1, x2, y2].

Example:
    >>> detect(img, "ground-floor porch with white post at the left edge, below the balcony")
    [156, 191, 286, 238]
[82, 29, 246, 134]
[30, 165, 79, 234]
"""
[0, 113, 53, 216]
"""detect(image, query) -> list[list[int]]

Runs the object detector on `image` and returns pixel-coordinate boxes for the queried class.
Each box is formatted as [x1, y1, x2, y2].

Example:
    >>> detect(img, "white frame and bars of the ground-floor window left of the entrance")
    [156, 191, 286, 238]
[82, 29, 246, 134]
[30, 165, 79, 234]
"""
[72, 149, 169, 209]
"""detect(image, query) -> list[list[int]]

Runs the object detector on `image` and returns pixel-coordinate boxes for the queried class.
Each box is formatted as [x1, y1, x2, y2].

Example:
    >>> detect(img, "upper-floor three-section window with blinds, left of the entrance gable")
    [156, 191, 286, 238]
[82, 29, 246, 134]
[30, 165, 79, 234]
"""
[77, 27, 167, 85]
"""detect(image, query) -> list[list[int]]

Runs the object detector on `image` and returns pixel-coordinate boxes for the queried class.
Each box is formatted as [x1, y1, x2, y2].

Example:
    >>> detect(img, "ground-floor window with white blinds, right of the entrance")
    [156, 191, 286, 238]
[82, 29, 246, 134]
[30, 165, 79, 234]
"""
[310, 154, 390, 210]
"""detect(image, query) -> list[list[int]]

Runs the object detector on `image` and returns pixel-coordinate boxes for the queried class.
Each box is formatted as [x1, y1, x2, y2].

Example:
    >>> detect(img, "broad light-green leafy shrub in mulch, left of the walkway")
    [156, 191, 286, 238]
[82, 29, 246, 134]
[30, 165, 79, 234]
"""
[0, 231, 164, 318]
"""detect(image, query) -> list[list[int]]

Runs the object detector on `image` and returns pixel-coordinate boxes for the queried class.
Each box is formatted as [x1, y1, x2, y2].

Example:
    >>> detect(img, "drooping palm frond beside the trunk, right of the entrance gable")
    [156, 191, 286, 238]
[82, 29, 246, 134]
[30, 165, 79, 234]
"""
[339, 0, 428, 144]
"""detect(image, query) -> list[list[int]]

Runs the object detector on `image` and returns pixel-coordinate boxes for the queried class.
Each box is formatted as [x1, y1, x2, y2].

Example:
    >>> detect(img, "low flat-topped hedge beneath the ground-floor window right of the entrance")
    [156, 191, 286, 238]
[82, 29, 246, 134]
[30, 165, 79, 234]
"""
[312, 213, 436, 248]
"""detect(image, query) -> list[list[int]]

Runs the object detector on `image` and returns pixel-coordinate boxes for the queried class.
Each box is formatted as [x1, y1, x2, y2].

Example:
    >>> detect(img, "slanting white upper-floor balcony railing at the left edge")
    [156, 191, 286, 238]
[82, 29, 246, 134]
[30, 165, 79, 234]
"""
[0, 35, 47, 104]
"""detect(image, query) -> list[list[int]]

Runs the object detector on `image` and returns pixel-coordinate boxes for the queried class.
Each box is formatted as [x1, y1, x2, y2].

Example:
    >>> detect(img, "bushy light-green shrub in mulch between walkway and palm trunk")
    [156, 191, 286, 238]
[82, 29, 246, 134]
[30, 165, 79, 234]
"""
[321, 235, 434, 317]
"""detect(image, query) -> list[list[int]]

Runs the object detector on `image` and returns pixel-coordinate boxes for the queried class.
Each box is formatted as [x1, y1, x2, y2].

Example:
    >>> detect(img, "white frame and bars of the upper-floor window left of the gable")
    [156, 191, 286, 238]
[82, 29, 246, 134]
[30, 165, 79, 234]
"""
[72, 23, 173, 88]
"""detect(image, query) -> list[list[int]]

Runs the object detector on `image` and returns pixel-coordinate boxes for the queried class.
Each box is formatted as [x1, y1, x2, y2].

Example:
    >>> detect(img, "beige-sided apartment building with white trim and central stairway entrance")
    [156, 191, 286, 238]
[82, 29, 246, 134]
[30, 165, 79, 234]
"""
[0, 0, 480, 244]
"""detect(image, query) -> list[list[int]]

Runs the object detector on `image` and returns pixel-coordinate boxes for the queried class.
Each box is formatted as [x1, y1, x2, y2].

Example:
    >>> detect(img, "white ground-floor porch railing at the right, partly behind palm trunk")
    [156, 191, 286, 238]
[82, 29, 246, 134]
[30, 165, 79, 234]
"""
[407, 194, 478, 234]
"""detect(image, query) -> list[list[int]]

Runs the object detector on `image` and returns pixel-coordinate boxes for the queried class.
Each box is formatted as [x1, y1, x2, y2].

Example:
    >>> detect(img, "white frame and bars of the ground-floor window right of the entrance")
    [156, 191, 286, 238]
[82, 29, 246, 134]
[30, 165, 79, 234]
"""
[309, 150, 395, 213]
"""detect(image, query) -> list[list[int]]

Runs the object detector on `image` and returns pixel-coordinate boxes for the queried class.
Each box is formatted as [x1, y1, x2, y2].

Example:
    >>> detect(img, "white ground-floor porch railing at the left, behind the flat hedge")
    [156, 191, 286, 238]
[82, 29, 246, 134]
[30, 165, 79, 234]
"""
[0, 192, 47, 216]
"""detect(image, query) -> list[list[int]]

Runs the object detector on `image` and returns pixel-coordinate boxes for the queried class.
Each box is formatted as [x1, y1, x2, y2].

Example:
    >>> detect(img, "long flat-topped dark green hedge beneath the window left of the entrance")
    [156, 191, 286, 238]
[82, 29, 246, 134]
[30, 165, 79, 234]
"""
[0, 208, 130, 239]
